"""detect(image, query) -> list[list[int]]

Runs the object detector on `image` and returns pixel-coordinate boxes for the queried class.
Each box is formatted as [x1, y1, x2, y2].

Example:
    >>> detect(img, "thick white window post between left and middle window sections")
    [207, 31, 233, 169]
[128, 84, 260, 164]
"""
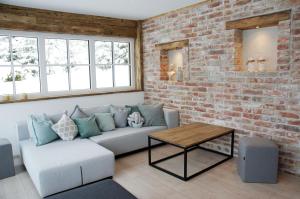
[38, 36, 48, 95]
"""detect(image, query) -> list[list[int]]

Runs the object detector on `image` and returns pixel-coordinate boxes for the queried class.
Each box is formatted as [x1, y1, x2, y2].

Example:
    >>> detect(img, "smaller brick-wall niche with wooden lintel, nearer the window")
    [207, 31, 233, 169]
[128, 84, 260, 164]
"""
[155, 40, 190, 82]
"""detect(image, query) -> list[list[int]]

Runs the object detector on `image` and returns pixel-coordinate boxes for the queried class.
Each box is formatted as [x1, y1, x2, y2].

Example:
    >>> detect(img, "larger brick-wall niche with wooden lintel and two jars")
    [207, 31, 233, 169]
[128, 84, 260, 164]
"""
[226, 10, 290, 72]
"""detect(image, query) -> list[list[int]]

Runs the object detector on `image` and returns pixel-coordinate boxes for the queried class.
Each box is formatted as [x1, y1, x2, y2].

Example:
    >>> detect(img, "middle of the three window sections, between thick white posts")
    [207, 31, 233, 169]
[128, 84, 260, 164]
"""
[45, 39, 90, 91]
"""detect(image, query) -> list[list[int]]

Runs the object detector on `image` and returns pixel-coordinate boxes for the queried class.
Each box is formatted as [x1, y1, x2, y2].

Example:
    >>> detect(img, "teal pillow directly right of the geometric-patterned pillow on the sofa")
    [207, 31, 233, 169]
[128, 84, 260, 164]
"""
[74, 115, 101, 138]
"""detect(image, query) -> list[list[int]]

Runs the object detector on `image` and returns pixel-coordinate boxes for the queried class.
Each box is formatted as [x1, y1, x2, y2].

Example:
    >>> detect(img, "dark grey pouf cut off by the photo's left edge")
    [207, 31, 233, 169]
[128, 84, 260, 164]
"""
[0, 139, 15, 180]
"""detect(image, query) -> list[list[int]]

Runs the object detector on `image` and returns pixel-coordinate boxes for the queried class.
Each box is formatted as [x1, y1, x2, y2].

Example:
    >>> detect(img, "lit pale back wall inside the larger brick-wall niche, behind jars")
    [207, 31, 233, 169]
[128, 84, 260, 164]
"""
[243, 26, 278, 71]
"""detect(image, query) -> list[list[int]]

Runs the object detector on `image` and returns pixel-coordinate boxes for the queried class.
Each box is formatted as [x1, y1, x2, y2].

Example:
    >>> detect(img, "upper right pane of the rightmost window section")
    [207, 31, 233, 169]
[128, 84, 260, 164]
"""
[114, 42, 129, 64]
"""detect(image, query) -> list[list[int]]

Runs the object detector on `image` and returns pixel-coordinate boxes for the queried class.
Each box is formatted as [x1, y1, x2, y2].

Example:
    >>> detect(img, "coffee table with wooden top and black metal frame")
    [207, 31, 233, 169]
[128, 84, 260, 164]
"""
[148, 123, 234, 181]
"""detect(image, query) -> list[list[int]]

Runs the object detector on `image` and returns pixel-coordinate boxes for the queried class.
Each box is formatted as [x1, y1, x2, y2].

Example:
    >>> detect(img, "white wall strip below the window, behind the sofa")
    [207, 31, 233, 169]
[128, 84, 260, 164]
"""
[0, 92, 144, 155]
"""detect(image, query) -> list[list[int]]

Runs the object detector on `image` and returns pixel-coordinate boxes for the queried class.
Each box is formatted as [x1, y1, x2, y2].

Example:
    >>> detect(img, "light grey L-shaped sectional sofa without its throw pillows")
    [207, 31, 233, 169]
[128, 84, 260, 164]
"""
[17, 108, 179, 197]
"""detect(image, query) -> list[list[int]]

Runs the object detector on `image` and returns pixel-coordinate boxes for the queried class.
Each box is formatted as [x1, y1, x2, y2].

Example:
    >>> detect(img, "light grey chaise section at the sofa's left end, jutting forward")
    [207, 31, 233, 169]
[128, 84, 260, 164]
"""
[20, 139, 114, 197]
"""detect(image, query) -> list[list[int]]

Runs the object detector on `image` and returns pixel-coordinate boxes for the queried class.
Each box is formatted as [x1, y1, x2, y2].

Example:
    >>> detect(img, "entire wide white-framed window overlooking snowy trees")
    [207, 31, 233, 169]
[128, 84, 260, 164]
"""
[0, 30, 134, 99]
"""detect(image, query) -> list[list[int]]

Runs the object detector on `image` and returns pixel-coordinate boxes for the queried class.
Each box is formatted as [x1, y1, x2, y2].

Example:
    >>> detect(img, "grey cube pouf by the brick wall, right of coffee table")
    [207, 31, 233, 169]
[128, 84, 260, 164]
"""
[238, 137, 278, 183]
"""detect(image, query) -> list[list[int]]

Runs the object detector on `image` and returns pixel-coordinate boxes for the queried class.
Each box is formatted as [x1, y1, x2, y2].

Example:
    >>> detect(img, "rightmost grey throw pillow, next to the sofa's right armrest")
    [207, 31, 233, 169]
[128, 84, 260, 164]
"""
[138, 104, 166, 126]
